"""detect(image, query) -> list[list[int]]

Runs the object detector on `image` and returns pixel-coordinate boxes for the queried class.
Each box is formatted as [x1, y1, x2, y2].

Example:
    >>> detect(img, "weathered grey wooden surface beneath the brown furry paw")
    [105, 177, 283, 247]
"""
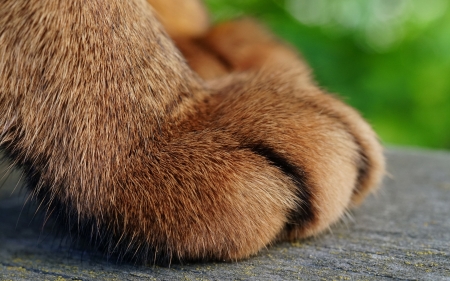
[0, 149, 450, 280]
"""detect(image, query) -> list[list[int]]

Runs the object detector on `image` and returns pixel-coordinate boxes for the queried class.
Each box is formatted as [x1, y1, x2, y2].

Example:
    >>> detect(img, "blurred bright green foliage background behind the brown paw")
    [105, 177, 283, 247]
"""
[206, 0, 450, 149]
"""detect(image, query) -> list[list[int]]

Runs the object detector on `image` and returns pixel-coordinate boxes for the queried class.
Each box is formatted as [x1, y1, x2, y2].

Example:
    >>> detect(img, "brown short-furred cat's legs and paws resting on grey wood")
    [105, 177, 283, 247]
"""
[0, 0, 384, 261]
